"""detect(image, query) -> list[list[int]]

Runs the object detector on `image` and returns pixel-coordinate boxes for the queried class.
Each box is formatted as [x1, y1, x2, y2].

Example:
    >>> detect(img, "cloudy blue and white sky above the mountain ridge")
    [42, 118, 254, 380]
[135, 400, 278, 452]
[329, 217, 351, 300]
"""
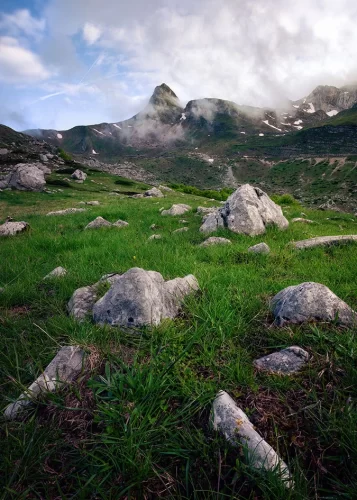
[0, 0, 357, 130]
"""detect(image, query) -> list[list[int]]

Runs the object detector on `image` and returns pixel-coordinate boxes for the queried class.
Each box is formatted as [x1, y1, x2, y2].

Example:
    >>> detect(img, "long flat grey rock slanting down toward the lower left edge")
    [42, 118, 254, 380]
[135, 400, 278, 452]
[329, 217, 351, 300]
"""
[4, 346, 84, 420]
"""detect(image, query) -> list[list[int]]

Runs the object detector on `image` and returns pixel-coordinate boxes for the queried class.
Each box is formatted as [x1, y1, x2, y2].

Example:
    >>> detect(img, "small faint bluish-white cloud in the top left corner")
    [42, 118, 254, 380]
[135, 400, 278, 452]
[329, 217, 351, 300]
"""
[0, 9, 46, 38]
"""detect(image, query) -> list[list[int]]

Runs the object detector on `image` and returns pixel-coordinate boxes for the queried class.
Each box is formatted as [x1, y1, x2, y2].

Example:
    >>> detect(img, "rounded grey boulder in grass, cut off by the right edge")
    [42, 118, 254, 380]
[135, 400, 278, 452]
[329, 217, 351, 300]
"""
[271, 282, 357, 326]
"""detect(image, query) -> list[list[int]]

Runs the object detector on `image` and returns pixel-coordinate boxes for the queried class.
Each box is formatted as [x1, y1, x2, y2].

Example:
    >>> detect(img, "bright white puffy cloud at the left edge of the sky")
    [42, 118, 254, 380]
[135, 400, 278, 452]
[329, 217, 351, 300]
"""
[0, 37, 50, 84]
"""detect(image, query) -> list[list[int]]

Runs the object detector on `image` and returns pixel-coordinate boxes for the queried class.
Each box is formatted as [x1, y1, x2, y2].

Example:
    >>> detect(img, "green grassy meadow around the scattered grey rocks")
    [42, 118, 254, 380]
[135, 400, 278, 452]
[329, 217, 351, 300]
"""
[0, 171, 357, 500]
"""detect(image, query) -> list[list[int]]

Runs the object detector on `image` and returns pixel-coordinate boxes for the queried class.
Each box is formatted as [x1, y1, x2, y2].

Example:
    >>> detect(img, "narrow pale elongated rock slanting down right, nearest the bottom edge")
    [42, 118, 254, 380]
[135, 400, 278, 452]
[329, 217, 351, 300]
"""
[213, 391, 293, 487]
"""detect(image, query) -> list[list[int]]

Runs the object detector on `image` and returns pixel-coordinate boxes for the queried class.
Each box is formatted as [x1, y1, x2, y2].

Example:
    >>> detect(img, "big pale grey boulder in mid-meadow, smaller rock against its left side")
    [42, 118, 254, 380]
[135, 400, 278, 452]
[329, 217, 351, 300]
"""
[93, 267, 199, 327]
